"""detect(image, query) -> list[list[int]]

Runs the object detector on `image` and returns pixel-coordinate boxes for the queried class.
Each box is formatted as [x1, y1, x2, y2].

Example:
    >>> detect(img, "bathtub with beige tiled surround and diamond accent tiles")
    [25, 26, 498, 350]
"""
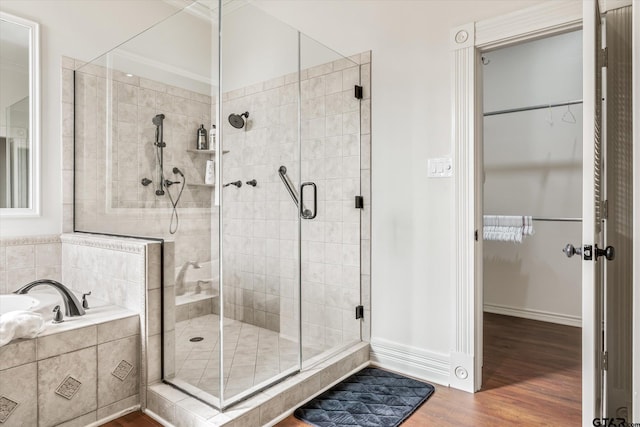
[0, 287, 141, 427]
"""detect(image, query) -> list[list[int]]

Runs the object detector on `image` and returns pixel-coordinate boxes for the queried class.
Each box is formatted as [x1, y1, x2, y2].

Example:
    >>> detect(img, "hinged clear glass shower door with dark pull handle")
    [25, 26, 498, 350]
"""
[300, 35, 361, 365]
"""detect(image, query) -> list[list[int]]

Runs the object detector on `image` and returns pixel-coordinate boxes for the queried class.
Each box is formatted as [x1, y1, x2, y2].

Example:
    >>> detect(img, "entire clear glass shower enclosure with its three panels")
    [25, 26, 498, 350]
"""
[74, 1, 361, 409]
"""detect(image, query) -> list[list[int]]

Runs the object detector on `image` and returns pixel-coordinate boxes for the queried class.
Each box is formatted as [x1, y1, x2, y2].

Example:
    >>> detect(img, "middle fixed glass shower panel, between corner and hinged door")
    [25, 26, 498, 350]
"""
[220, 1, 300, 405]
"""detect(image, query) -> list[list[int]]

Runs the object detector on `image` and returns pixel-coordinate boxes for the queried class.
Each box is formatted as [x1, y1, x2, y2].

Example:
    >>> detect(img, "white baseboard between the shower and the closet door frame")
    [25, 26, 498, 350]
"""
[371, 338, 449, 386]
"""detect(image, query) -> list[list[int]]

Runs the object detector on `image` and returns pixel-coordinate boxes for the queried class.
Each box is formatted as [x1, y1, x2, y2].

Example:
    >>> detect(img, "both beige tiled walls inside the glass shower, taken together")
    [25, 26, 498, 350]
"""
[68, 49, 371, 347]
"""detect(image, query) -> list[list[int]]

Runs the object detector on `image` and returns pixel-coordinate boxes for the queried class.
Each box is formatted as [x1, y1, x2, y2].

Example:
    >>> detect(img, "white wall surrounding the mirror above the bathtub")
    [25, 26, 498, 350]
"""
[0, 0, 188, 237]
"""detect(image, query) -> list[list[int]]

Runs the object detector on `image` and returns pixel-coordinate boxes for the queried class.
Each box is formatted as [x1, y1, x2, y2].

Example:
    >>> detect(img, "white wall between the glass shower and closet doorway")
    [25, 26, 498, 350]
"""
[254, 0, 542, 374]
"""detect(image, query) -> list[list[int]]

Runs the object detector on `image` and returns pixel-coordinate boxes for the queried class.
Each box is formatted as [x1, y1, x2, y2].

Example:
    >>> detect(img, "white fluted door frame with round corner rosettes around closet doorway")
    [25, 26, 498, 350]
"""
[449, 0, 640, 421]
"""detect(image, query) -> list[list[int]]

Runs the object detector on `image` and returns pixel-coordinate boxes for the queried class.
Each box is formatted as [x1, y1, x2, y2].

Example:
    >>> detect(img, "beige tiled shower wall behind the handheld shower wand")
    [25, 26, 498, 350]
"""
[71, 59, 218, 286]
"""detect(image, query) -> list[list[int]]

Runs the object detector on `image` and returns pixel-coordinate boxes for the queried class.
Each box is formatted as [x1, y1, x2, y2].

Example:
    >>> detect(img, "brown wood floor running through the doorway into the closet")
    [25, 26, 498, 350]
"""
[104, 313, 581, 427]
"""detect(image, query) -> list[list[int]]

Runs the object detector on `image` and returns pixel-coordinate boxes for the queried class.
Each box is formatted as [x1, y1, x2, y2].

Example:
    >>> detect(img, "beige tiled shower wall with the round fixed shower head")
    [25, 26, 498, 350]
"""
[223, 53, 371, 349]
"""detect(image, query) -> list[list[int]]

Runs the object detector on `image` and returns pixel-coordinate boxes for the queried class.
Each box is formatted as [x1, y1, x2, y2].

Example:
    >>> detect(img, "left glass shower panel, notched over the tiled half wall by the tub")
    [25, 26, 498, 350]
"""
[74, 3, 220, 406]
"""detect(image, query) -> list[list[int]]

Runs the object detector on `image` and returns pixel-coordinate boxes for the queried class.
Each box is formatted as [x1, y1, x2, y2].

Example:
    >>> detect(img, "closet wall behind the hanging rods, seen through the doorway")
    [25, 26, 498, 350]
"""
[482, 31, 582, 326]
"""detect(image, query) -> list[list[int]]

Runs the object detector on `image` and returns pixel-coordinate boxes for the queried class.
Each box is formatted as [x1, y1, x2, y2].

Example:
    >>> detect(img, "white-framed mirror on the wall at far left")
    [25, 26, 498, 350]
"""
[0, 12, 40, 216]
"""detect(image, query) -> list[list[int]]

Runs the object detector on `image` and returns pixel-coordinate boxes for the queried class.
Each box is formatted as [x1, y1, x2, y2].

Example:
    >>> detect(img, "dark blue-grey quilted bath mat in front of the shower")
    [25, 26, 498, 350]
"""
[293, 368, 434, 427]
